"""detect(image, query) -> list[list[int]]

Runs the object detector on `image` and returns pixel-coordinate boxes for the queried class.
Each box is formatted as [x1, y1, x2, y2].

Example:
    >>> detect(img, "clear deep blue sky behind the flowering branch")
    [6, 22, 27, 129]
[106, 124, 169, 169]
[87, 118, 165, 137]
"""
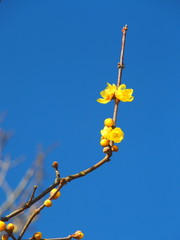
[0, 0, 180, 240]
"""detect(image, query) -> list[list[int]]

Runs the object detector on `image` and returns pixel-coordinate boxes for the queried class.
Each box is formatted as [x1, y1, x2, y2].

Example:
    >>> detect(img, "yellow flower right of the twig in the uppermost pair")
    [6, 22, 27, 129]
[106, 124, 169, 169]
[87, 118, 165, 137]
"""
[115, 84, 134, 102]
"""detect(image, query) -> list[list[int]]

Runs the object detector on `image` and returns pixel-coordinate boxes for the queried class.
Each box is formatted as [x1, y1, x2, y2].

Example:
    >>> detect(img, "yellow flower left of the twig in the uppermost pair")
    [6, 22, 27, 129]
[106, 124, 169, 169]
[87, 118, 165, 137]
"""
[97, 83, 116, 104]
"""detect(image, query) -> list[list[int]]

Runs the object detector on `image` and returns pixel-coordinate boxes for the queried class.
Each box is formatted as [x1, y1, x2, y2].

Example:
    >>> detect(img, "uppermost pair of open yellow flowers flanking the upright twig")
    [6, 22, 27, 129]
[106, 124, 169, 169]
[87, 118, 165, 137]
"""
[97, 83, 134, 104]
